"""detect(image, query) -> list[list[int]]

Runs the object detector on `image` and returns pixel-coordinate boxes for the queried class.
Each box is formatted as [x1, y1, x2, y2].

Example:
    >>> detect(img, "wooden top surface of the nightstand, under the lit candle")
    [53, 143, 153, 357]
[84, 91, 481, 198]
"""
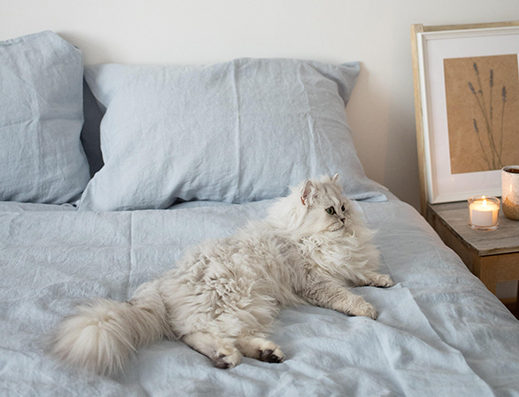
[427, 201, 519, 256]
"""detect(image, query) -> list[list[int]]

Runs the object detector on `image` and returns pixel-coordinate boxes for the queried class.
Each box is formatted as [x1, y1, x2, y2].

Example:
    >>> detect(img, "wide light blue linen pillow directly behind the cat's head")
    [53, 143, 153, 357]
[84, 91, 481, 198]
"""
[80, 59, 383, 211]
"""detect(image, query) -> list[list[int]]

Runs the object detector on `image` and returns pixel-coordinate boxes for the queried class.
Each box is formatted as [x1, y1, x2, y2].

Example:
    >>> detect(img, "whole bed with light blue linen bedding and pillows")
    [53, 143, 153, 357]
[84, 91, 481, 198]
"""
[0, 32, 519, 396]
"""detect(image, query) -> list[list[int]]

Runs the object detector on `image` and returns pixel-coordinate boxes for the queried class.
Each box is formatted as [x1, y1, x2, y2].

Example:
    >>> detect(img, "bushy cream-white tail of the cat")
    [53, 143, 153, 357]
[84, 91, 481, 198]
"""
[51, 283, 170, 375]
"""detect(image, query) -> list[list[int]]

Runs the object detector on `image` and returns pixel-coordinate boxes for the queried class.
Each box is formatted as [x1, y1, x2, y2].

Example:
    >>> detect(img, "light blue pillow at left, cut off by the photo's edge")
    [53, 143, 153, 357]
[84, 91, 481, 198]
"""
[0, 31, 90, 204]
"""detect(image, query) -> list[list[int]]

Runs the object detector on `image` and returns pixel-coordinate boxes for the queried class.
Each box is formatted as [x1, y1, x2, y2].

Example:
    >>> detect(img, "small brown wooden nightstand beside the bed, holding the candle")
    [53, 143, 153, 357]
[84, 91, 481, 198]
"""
[426, 201, 519, 312]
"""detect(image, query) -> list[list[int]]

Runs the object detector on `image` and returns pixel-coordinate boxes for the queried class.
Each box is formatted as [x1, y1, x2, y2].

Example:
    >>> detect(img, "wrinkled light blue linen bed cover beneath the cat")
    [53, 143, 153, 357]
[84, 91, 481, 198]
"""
[0, 198, 519, 397]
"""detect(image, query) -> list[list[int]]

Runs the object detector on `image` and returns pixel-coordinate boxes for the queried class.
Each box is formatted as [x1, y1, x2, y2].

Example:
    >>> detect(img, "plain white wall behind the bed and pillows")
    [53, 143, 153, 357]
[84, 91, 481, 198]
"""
[0, 0, 519, 207]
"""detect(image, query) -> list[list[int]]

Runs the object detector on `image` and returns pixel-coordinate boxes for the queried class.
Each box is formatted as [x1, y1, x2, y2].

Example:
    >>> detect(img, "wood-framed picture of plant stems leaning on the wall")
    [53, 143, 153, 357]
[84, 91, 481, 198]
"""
[411, 21, 519, 213]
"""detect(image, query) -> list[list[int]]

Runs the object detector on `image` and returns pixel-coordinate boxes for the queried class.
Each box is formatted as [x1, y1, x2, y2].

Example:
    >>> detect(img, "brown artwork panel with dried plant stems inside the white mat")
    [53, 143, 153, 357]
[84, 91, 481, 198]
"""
[444, 54, 519, 174]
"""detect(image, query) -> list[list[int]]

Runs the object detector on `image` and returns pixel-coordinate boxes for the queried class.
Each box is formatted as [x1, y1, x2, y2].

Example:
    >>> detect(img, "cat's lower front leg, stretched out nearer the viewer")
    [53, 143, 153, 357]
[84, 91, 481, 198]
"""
[301, 272, 377, 320]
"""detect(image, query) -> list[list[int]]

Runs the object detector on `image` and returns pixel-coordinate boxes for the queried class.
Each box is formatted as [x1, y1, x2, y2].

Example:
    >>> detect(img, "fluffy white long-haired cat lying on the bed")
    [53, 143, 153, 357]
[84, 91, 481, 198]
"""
[52, 175, 393, 375]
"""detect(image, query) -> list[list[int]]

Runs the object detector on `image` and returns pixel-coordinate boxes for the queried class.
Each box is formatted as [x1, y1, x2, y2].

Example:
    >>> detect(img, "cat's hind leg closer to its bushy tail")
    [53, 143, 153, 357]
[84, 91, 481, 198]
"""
[182, 332, 241, 369]
